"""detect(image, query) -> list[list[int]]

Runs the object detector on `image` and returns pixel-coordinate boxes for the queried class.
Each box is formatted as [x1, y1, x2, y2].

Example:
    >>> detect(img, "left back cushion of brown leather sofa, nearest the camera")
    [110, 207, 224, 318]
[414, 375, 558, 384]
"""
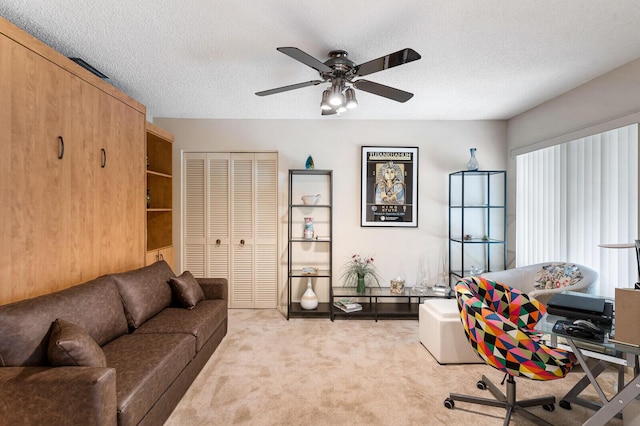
[0, 276, 128, 367]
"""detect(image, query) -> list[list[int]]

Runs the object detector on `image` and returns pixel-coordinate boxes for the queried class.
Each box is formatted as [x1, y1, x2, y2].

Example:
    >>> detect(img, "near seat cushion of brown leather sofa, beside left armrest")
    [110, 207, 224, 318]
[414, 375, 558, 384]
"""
[102, 332, 195, 425]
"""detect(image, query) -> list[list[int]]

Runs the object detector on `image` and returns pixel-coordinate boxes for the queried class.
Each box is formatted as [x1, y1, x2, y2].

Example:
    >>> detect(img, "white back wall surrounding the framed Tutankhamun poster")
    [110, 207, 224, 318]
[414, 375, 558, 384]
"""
[154, 118, 507, 310]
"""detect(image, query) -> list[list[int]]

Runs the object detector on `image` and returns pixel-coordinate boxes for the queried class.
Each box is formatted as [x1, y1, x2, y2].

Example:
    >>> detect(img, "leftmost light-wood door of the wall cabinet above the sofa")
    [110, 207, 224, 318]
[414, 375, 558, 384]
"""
[0, 32, 71, 296]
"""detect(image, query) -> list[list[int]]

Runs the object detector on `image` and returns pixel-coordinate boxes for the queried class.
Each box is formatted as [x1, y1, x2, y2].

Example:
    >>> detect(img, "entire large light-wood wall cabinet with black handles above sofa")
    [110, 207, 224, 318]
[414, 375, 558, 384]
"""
[0, 18, 145, 304]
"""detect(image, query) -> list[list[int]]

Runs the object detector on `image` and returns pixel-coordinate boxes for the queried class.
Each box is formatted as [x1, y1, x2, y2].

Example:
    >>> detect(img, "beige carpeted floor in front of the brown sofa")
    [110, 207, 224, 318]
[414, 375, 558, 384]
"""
[166, 309, 622, 426]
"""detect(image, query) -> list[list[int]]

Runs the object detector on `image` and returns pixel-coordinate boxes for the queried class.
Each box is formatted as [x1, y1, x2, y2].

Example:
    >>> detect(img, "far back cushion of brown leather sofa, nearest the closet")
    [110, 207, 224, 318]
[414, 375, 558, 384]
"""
[111, 261, 175, 329]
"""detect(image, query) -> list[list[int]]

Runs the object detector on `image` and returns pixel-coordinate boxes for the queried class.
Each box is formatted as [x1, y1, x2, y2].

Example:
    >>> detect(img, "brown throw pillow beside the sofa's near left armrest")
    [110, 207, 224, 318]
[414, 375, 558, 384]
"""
[47, 319, 107, 367]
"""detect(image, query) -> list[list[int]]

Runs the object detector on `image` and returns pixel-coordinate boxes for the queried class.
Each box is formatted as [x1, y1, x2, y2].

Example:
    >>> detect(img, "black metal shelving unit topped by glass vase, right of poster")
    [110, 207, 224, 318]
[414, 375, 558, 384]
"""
[449, 170, 507, 284]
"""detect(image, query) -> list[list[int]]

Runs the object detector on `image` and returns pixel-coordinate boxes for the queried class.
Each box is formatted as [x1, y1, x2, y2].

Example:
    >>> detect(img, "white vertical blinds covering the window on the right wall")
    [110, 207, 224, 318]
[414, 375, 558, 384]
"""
[516, 124, 639, 297]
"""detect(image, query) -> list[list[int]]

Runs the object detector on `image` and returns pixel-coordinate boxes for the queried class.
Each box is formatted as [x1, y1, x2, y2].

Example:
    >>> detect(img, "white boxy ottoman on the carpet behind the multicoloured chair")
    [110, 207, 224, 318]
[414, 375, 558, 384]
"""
[418, 299, 483, 364]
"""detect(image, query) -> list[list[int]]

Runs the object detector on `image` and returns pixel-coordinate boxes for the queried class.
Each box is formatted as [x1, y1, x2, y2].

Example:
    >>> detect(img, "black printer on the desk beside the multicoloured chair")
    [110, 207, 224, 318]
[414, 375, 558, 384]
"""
[547, 293, 613, 325]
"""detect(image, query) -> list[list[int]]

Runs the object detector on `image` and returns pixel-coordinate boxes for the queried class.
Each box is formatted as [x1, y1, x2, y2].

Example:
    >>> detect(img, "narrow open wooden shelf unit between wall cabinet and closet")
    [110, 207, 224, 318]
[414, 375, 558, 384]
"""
[146, 122, 175, 268]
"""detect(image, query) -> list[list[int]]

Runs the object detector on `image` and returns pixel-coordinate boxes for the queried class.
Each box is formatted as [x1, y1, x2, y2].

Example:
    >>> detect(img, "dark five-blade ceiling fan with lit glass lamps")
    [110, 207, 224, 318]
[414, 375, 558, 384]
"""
[256, 47, 421, 115]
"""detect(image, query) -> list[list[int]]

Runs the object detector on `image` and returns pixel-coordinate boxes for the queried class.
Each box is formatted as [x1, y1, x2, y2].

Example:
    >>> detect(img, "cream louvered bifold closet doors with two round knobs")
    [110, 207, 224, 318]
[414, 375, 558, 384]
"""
[182, 152, 278, 308]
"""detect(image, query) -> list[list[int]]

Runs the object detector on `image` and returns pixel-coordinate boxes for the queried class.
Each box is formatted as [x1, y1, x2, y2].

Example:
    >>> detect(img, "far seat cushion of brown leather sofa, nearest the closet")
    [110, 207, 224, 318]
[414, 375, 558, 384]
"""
[134, 300, 227, 351]
